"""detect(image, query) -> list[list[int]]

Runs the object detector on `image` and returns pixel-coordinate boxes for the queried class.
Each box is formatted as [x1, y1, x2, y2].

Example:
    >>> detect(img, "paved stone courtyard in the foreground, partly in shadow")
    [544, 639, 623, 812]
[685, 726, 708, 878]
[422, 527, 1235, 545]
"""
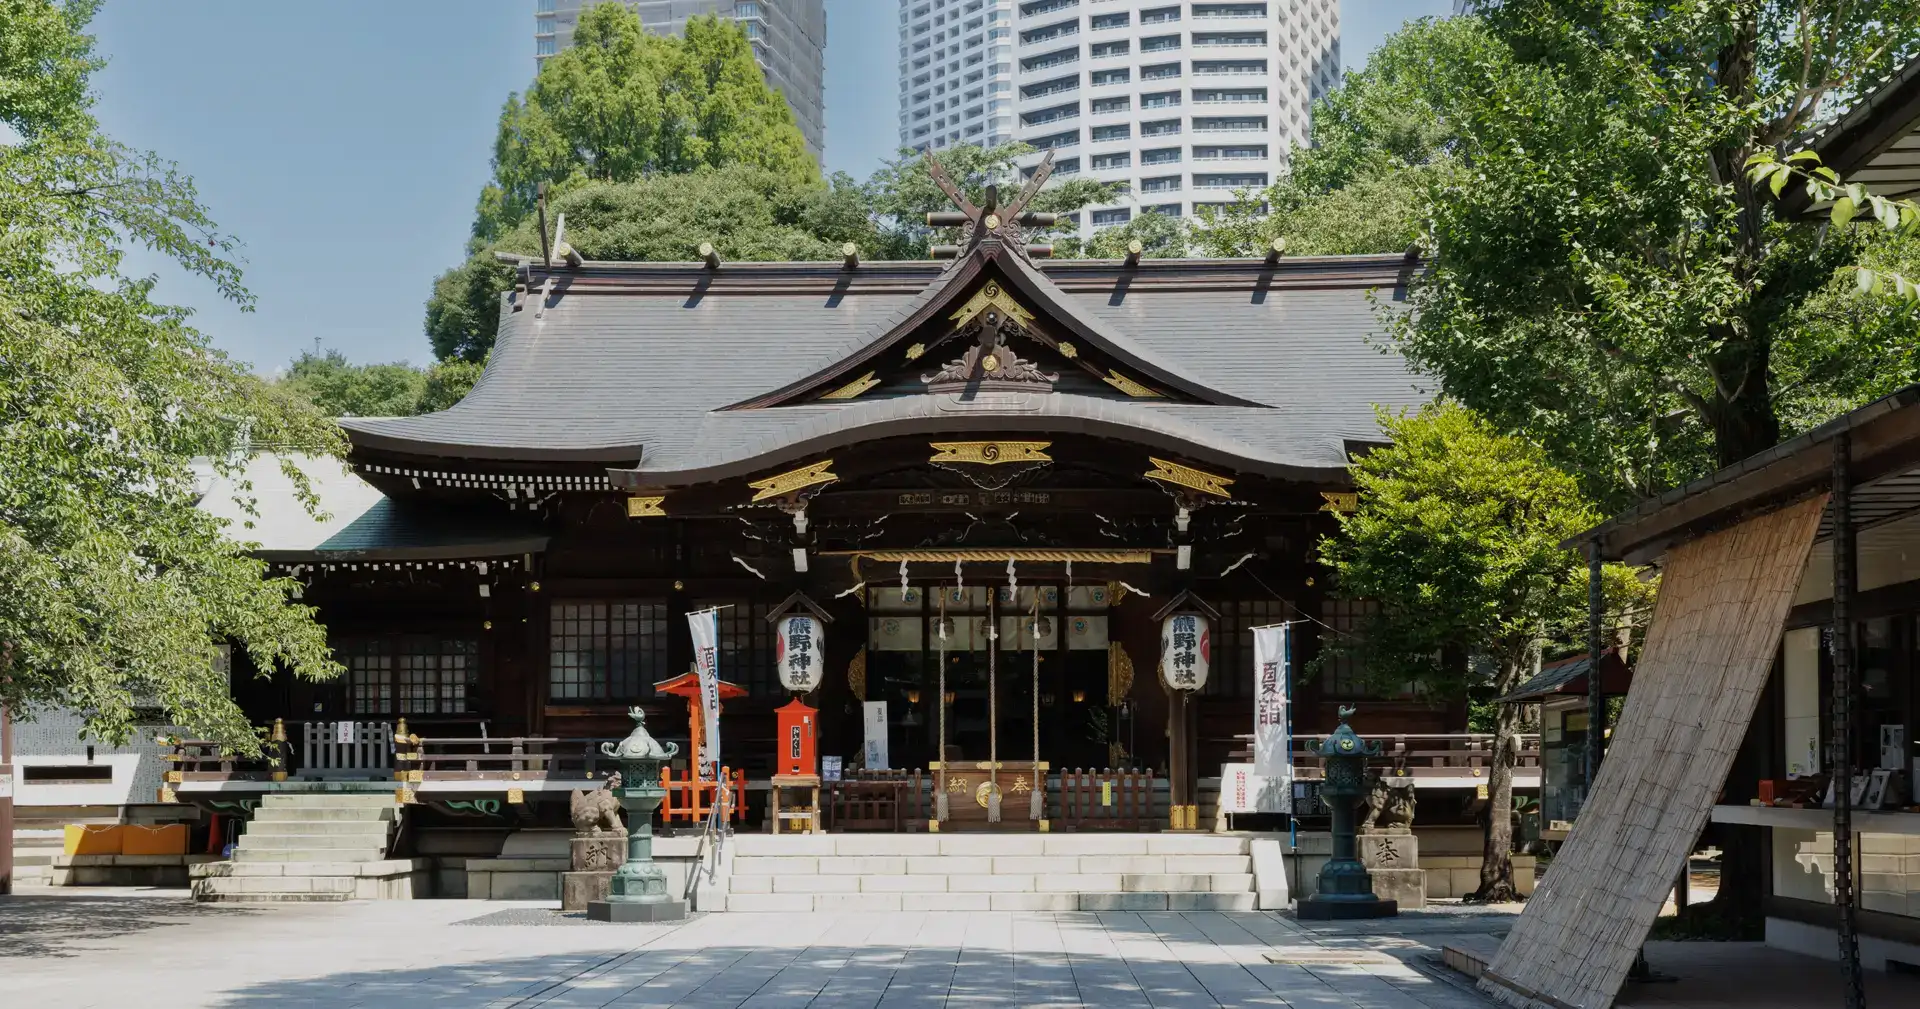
[0, 890, 1920, 1009]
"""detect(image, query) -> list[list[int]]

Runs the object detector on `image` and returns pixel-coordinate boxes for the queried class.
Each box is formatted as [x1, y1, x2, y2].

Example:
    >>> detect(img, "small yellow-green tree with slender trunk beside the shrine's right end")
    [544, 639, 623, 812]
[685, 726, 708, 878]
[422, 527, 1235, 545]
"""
[1321, 403, 1632, 900]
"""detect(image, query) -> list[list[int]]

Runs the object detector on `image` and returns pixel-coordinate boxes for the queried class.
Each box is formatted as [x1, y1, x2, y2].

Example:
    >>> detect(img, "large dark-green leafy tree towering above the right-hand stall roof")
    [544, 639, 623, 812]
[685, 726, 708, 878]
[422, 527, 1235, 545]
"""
[1396, 0, 1920, 505]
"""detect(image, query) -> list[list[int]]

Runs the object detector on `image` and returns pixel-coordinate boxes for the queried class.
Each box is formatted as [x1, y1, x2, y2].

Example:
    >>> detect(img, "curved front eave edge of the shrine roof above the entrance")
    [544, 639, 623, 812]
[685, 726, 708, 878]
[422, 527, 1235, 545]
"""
[607, 393, 1348, 489]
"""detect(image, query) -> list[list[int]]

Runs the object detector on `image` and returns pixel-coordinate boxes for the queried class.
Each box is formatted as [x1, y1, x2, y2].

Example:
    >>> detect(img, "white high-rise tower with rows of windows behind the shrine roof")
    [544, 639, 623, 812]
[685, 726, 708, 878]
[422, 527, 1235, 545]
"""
[900, 0, 1340, 234]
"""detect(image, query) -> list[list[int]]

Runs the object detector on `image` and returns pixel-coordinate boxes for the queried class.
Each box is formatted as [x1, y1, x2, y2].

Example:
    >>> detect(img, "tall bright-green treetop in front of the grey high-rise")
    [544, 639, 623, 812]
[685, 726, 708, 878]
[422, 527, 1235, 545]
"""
[474, 4, 820, 247]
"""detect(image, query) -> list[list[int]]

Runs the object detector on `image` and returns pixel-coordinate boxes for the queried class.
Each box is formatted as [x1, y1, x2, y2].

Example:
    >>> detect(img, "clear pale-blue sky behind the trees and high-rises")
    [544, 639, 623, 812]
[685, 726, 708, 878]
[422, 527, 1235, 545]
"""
[82, 0, 1452, 372]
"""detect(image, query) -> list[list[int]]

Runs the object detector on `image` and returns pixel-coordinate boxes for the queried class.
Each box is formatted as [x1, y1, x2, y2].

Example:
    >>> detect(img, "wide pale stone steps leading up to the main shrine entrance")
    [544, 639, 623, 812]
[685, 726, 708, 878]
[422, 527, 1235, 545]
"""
[726, 834, 1256, 911]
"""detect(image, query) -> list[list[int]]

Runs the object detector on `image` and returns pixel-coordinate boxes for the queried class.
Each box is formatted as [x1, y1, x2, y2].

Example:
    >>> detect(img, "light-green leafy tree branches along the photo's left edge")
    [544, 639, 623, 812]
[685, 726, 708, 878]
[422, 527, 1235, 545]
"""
[0, 0, 340, 746]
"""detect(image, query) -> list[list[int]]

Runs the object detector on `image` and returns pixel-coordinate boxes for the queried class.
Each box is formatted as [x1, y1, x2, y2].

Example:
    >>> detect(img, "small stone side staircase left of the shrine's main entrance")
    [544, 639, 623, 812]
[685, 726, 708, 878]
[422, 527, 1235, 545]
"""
[192, 788, 428, 902]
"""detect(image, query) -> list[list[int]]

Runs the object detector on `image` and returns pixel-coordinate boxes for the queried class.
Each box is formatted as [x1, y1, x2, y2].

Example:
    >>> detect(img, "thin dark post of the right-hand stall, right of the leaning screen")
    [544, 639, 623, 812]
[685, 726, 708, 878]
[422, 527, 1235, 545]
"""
[1828, 432, 1866, 1009]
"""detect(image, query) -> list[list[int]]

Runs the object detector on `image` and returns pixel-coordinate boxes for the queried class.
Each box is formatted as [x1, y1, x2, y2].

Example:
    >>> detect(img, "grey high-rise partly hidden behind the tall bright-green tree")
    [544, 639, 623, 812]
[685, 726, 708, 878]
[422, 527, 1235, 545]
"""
[534, 0, 828, 159]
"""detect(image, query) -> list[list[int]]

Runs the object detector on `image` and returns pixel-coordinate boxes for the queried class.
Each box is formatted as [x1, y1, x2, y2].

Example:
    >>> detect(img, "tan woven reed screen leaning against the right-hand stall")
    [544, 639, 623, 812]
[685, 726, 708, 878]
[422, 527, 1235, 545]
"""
[1480, 495, 1826, 1009]
